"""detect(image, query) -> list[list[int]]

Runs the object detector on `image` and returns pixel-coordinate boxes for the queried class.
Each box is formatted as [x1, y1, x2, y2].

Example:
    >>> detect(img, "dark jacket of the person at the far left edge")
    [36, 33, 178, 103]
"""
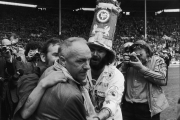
[0, 56, 18, 120]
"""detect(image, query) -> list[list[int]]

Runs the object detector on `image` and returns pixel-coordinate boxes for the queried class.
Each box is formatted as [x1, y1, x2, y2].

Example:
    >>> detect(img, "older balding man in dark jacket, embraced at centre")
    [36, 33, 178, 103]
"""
[27, 37, 91, 120]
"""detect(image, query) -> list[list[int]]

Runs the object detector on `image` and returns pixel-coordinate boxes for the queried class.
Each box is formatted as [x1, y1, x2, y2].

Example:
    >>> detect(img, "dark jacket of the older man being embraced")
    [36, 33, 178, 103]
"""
[31, 82, 86, 120]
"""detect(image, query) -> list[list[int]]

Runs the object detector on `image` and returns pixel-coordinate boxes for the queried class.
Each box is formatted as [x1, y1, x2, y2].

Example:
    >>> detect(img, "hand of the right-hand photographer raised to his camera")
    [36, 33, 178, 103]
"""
[129, 54, 144, 70]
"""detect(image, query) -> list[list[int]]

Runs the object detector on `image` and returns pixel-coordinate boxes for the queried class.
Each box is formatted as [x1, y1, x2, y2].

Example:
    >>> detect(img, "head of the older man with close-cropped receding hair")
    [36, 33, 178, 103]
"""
[59, 37, 91, 84]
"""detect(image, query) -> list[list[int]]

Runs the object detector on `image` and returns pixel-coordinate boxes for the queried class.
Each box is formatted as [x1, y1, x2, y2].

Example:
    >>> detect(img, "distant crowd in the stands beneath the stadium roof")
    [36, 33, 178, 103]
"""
[0, 9, 180, 59]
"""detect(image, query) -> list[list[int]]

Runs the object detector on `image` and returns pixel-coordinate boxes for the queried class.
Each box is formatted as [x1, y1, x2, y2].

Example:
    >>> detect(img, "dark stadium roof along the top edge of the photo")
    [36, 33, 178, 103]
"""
[0, 0, 180, 11]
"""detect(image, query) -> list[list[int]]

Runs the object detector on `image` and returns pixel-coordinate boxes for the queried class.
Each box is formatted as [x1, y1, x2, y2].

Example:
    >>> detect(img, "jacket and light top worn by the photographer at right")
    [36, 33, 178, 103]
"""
[120, 56, 169, 116]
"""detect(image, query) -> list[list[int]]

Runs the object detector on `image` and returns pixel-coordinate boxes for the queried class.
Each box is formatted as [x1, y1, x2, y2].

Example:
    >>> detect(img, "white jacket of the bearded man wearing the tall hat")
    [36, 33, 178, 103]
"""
[87, 65, 124, 120]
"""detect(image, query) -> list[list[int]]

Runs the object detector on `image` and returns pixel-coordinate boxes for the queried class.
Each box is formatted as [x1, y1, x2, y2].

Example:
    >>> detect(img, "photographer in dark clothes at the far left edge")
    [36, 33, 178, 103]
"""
[0, 39, 19, 120]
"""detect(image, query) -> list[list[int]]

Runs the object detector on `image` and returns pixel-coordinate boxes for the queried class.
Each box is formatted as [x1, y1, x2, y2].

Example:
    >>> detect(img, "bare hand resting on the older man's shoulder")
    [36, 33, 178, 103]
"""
[39, 71, 67, 88]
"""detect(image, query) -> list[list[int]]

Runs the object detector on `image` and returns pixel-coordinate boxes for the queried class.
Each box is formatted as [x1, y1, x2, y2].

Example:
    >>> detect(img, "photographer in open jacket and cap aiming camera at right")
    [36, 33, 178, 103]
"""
[120, 40, 168, 120]
